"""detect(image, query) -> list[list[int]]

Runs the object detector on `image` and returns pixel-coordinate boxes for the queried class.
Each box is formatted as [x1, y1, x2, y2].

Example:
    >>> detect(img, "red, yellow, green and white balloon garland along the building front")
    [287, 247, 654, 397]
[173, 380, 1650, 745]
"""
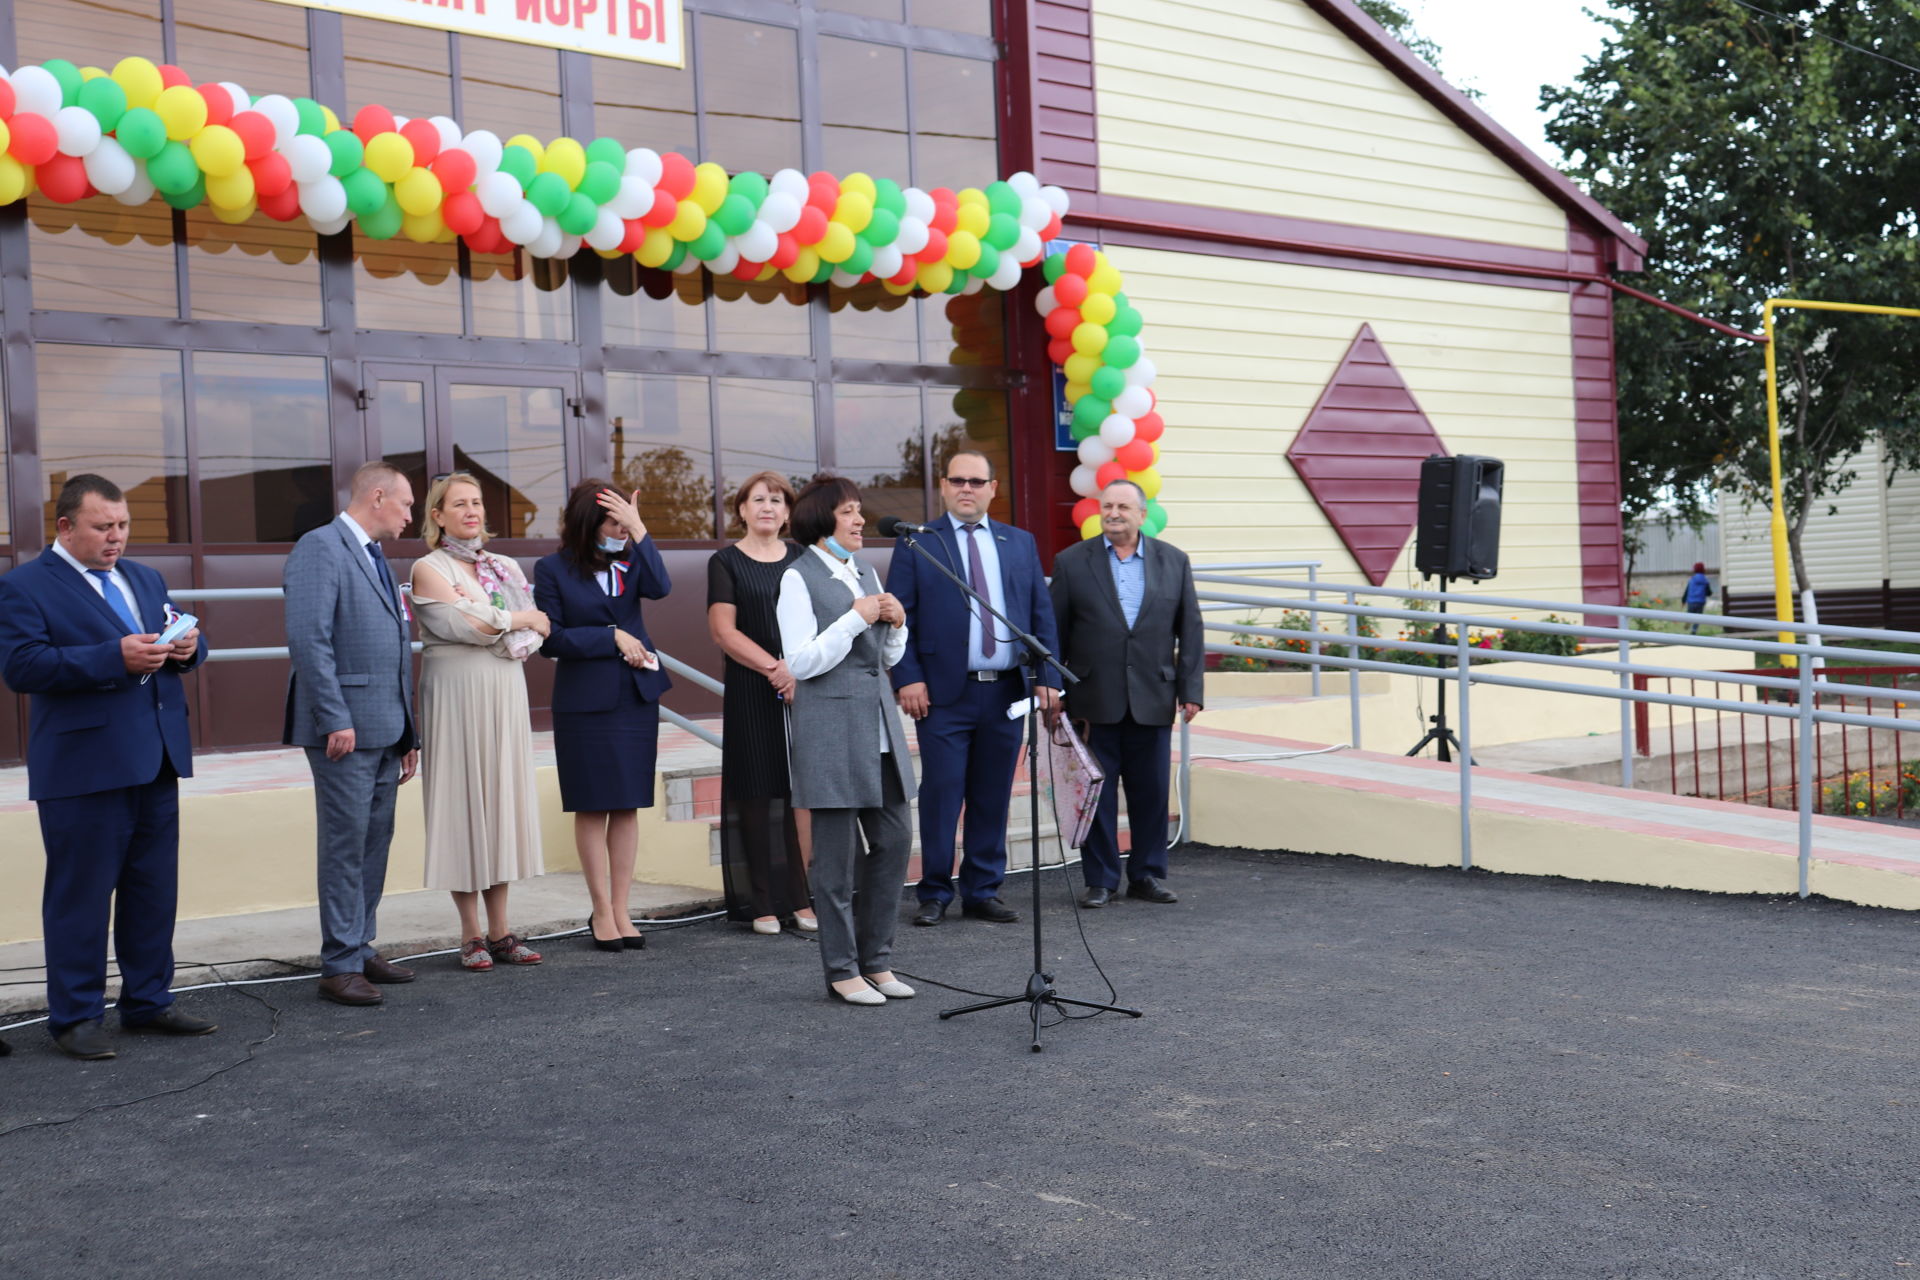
[0, 58, 1167, 537]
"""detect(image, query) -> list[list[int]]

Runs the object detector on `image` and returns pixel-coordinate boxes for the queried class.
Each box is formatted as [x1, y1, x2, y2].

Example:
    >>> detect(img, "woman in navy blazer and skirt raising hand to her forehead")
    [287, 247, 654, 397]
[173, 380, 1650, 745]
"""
[534, 480, 672, 952]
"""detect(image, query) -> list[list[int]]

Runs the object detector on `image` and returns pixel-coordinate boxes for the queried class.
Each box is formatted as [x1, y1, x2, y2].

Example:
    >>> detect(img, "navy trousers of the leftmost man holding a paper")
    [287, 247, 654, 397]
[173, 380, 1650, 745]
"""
[38, 760, 180, 1034]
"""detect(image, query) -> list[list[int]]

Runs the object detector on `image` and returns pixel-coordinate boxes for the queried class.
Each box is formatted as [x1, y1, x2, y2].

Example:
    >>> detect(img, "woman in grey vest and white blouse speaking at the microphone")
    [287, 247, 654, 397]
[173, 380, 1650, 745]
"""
[776, 476, 914, 1006]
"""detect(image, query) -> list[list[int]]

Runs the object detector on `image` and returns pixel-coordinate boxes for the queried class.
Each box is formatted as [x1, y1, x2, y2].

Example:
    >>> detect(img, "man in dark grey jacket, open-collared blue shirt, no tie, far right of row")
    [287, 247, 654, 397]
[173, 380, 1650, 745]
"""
[1052, 480, 1206, 908]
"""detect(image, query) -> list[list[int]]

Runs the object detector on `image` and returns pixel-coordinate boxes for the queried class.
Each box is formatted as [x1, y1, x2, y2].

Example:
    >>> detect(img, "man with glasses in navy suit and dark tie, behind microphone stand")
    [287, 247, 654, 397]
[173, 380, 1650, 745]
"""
[887, 451, 1058, 925]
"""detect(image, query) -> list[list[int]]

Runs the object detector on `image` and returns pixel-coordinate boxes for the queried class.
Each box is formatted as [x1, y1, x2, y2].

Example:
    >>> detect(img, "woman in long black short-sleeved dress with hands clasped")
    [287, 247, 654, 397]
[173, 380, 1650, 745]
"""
[707, 472, 820, 933]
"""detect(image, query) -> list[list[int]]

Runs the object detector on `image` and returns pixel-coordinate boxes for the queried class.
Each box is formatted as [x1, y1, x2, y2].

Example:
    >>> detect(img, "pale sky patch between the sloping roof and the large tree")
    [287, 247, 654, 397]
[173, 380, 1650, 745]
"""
[1402, 0, 1611, 165]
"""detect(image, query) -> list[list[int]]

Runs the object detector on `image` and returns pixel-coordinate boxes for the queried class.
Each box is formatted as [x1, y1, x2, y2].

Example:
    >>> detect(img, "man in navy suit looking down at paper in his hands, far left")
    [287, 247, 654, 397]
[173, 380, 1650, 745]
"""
[0, 474, 215, 1059]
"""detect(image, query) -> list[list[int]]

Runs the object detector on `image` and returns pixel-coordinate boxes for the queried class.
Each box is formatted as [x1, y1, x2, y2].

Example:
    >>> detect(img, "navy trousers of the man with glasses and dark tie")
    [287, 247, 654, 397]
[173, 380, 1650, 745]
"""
[918, 672, 1025, 902]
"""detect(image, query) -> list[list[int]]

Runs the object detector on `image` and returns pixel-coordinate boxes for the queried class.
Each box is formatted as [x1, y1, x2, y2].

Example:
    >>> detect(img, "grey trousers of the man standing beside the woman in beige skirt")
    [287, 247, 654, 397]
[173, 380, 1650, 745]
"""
[307, 747, 403, 977]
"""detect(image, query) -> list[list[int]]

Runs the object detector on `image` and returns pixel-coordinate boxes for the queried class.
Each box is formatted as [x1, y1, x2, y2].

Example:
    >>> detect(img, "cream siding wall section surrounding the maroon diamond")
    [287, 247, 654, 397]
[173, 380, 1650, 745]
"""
[1108, 248, 1580, 601]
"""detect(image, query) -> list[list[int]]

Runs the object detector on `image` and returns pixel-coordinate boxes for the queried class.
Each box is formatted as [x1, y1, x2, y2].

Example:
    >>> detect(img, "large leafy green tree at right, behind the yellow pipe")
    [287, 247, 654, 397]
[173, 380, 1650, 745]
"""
[1542, 0, 1920, 589]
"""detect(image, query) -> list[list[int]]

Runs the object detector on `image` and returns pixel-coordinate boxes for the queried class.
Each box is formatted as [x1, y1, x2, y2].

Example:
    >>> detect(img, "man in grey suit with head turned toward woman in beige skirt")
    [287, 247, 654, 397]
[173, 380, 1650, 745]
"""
[284, 462, 420, 1004]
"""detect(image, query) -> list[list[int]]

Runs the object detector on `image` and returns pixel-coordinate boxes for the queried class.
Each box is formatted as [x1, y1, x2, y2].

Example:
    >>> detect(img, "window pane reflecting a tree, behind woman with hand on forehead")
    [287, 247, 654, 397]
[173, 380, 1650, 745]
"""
[607, 374, 714, 539]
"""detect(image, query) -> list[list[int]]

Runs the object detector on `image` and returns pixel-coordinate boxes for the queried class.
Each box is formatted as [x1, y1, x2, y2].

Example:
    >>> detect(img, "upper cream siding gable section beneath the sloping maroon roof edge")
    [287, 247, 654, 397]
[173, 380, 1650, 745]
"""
[1092, 0, 1567, 249]
